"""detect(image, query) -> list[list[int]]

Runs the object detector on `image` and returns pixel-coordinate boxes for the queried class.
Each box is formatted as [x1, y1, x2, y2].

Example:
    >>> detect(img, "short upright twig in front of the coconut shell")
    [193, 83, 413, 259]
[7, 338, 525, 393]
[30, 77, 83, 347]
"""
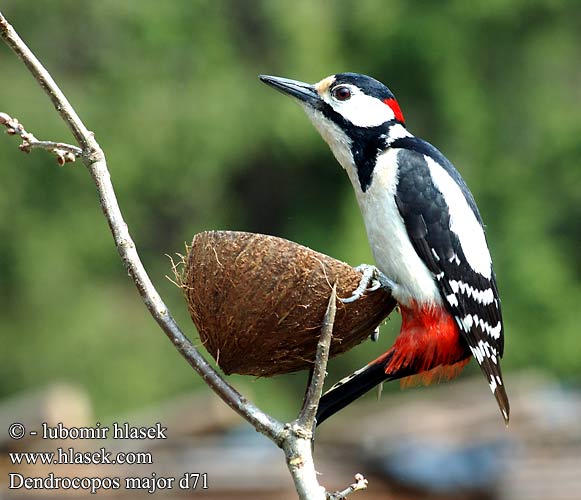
[297, 284, 337, 432]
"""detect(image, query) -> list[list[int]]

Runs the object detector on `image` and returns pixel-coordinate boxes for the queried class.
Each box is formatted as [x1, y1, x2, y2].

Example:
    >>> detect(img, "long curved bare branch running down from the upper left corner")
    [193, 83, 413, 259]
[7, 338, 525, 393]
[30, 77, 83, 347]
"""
[0, 7, 284, 446]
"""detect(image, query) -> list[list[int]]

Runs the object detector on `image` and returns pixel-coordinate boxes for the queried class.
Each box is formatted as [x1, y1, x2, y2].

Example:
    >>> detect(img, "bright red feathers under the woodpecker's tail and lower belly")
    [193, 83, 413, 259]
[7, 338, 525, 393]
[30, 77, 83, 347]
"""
[385, 303, 470, 384]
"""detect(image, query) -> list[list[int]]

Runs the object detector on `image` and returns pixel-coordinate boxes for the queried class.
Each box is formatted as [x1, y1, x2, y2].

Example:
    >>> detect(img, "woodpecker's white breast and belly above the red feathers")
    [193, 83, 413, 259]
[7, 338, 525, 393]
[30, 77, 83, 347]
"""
[350, 146, 442, 305]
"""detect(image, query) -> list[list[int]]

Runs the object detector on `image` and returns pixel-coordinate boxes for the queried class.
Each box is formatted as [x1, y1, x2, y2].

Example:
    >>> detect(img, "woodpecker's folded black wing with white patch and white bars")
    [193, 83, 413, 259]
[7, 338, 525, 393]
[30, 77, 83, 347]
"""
[391, 137, 510, 422]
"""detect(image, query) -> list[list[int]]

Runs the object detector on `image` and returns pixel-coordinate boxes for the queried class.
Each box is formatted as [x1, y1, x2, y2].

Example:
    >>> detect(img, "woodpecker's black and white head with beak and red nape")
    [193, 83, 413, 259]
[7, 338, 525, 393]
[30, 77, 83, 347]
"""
[260, 73, 408, 184]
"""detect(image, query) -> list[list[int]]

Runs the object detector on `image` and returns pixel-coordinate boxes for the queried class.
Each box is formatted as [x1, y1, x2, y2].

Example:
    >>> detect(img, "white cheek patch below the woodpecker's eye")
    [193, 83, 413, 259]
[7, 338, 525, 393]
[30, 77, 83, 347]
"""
[323, 91, 395, 127]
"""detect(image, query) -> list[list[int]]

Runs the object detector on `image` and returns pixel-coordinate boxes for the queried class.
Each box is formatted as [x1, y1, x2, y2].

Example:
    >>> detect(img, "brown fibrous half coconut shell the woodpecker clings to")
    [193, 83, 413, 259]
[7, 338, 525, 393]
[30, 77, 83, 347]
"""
[177, 231, 395, 377]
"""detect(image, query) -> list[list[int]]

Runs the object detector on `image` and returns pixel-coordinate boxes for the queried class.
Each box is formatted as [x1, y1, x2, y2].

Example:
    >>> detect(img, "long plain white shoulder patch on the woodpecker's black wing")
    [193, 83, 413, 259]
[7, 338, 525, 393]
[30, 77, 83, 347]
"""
[424, 156, 492, 279]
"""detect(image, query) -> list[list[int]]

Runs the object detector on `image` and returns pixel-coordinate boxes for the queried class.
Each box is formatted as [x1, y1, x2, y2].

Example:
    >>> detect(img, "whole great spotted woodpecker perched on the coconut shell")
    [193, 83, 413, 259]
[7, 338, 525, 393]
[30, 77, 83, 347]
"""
[260, 73, 509, 424]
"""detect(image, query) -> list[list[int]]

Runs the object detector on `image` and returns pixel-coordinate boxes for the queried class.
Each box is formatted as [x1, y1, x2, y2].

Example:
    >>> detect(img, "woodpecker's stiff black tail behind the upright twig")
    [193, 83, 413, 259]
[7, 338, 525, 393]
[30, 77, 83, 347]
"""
[316, 362, 394, 425]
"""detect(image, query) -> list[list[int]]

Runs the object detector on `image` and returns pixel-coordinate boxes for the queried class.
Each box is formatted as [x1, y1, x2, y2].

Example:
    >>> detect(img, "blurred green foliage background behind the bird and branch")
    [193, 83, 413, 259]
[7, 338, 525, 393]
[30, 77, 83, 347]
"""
[0, 0, 581, 417]
